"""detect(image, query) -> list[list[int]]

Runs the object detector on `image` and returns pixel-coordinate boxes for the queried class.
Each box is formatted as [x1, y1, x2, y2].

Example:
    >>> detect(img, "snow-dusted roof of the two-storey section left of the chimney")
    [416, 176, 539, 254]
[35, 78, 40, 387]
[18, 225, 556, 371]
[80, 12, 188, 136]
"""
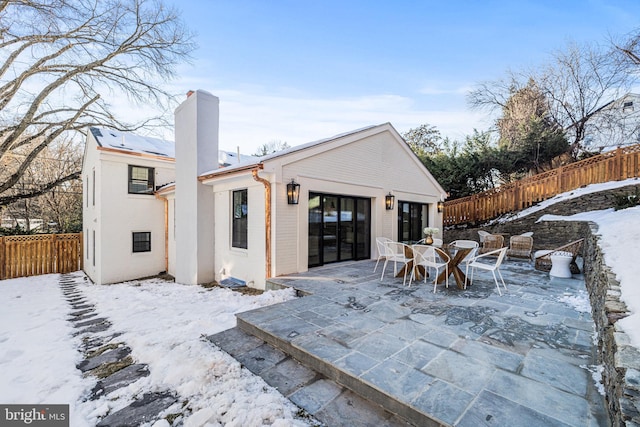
[91, 127, 176, 158]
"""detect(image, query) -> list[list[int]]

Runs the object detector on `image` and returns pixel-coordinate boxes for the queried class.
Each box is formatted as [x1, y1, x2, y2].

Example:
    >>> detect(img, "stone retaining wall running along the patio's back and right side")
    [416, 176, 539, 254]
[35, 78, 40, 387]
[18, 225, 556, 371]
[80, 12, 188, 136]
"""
[444, 185, 640, 427]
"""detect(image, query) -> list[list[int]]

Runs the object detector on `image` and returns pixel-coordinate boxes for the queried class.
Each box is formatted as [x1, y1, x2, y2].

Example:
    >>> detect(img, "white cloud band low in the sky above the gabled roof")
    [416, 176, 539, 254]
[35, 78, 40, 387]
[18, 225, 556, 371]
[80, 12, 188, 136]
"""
[208, 90, 489, 153]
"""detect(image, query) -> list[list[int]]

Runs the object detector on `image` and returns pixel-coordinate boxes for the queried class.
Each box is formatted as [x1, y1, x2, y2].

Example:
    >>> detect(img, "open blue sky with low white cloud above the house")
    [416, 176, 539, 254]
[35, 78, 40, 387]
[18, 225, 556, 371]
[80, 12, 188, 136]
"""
[161, 0, 640, 154]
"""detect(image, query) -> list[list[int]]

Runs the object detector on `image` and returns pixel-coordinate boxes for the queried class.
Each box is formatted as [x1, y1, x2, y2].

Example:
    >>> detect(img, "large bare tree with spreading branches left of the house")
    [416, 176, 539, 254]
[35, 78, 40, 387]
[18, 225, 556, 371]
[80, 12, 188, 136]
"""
[0, 0, 194, 206]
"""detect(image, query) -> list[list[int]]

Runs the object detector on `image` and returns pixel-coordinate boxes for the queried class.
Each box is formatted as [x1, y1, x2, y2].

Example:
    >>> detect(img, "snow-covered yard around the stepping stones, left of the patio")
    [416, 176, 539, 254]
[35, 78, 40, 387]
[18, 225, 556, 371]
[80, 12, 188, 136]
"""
[0, 273, 306, 427]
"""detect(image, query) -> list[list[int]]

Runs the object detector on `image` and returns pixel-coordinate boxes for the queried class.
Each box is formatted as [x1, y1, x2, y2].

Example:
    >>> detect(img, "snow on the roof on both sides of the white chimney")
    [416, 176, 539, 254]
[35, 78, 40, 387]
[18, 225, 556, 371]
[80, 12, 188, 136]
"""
[90, 127, 257, 167]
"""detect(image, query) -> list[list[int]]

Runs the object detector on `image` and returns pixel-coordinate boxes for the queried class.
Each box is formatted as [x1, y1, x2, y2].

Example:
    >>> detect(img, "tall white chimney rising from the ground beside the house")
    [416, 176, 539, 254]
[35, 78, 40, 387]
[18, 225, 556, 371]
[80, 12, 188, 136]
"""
[175, 90, 220, 285]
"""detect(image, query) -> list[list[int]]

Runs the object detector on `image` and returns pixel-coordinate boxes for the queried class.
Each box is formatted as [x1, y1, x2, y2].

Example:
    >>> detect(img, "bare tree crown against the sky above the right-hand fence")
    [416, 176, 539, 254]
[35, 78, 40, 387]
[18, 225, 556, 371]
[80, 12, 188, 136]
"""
[468, 43, 633, 157]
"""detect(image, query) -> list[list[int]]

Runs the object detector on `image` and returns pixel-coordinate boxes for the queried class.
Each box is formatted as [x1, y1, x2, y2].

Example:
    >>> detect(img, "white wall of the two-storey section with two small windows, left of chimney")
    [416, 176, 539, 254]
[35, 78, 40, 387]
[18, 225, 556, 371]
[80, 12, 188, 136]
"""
[83, 130, 175, 284]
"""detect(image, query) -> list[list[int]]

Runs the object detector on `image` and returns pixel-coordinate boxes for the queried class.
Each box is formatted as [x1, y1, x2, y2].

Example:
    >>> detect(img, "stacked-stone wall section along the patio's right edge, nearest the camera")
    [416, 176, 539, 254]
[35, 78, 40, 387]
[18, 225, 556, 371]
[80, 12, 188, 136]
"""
[583, 224, 640, 427]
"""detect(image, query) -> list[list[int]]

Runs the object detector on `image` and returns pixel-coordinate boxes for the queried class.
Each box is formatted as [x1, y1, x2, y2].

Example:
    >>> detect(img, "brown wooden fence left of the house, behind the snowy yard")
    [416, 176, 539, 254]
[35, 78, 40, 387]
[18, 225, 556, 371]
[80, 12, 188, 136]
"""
[0, 233, 82, 280]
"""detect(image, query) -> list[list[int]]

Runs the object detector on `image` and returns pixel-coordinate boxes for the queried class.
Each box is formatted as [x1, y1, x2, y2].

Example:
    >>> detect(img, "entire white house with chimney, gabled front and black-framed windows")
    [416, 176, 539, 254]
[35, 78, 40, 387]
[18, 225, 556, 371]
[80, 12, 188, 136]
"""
[83, 91, 445, 289]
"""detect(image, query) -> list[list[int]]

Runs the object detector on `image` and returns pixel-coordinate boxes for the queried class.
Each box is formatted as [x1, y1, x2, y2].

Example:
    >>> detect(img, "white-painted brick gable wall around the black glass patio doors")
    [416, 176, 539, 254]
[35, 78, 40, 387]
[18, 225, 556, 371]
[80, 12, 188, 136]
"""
[265, 126, 443, 276]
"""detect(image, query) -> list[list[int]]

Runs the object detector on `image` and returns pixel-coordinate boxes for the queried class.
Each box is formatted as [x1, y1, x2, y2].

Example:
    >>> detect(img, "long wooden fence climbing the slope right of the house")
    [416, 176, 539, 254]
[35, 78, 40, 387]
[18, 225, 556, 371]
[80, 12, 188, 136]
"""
[443, 145, 640, 225]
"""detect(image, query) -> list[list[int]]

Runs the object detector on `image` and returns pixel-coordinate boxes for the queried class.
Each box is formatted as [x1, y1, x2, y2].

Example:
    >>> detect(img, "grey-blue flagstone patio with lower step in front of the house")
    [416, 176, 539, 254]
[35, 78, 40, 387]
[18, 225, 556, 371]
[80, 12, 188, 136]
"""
[210, 260, 609, 426]
